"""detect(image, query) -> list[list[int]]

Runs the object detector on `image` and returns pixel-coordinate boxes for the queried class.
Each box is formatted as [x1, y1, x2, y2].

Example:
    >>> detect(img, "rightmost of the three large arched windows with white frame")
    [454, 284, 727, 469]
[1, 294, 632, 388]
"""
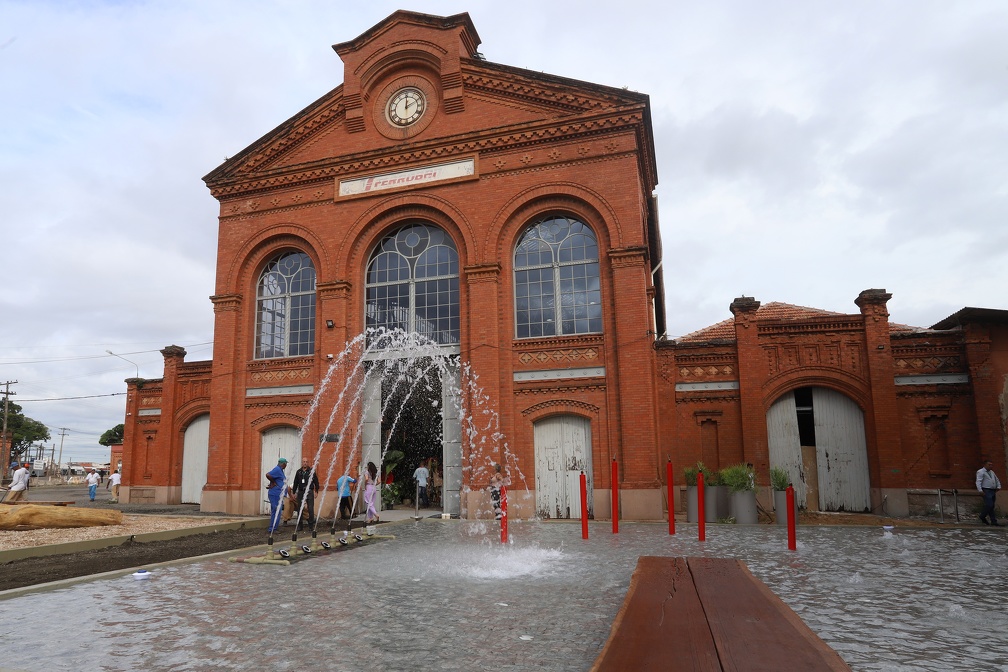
[514, 217, 602, 339]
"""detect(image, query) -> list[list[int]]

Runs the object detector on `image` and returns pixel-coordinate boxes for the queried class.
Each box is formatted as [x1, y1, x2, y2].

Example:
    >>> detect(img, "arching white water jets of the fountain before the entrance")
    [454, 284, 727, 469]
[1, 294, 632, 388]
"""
[244, 328, 528, 564]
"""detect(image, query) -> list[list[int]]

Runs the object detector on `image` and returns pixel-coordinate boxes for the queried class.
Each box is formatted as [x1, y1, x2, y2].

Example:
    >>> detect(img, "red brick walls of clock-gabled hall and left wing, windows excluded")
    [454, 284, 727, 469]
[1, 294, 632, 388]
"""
[119, 11, 663, 518]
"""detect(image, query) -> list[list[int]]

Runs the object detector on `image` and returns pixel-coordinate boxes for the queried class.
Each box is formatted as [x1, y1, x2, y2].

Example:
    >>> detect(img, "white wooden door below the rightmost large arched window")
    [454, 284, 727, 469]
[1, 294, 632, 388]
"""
[533, 415, 594, 518]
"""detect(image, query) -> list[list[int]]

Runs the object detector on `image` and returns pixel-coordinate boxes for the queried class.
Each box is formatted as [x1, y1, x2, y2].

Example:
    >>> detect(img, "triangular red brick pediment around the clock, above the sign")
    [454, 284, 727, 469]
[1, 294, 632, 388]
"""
[205, 12, 647, 194]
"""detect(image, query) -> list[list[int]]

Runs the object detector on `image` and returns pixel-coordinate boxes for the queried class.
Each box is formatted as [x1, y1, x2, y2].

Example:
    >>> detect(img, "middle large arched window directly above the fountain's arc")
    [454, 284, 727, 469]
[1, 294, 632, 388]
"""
[365, 223, 459, 346]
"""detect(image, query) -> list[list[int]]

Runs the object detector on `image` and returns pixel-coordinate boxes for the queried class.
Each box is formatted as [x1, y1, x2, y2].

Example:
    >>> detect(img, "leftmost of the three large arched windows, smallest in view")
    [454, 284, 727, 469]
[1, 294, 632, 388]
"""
[255, 252, 316, 360]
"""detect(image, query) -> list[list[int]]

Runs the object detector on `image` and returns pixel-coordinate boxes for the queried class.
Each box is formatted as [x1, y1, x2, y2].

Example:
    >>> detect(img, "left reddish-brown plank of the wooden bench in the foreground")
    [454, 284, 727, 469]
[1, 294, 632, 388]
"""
[592, 556, 725, 672]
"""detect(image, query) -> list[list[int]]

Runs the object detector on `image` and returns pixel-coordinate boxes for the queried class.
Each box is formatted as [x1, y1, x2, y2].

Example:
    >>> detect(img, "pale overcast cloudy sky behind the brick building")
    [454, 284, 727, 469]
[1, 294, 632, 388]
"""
[0, 0, 1008, 461]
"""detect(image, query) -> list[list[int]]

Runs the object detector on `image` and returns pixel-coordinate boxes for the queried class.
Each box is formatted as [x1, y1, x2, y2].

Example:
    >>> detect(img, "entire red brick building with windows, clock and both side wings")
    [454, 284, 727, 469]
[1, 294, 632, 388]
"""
[115, 11, 1008, 519]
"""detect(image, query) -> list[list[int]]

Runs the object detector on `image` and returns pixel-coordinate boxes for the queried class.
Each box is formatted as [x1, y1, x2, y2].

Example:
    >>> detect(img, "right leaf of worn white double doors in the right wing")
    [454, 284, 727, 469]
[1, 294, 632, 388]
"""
[812, 387, 871, 511]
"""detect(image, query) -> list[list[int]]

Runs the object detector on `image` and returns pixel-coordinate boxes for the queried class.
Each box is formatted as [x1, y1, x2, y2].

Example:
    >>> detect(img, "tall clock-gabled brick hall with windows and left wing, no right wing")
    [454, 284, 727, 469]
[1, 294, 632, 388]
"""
[117, 11, 664, 517]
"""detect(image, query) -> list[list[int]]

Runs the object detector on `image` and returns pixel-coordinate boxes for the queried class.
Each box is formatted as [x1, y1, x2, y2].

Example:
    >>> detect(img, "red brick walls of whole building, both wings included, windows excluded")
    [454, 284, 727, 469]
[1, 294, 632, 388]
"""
[115, 11, 1008, 519]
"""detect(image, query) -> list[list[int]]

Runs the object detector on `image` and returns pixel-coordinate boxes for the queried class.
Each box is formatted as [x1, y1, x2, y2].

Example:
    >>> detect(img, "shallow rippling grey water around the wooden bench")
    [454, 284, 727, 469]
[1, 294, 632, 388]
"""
[0, 509, 1008, 671]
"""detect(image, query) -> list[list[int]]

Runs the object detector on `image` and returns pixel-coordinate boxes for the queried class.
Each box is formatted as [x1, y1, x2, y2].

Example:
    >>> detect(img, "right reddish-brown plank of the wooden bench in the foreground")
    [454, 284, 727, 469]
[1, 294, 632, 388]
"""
[686, 557, 851, 672]
